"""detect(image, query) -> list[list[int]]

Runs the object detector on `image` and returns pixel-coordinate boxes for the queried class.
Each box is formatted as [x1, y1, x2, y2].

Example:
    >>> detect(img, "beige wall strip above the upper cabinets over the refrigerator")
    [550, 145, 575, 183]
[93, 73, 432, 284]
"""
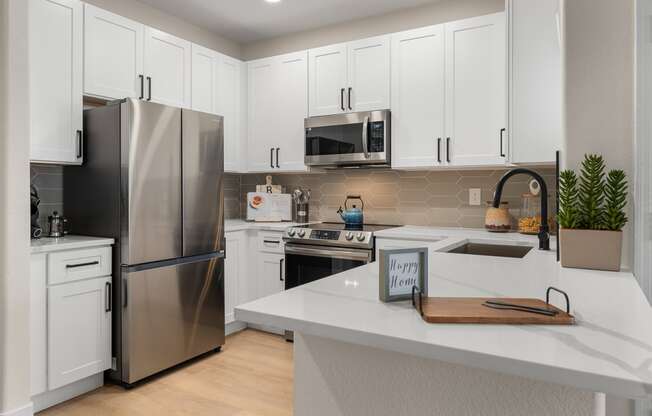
[84, 0, 241, 59]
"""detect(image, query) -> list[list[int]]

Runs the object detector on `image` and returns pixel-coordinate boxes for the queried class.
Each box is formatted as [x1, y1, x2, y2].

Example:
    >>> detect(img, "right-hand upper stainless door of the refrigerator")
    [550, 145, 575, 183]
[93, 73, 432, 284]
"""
[181, 110, 224, 256]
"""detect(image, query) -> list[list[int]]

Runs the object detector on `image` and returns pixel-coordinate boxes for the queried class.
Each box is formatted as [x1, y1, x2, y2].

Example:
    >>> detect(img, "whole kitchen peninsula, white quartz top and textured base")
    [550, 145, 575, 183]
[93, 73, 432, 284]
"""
[236, 227, 652, 416]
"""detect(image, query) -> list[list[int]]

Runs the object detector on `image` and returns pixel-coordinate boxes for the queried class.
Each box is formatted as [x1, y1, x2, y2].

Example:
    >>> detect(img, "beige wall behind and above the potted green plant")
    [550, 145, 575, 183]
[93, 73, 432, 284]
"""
[562, 0, 634, 267]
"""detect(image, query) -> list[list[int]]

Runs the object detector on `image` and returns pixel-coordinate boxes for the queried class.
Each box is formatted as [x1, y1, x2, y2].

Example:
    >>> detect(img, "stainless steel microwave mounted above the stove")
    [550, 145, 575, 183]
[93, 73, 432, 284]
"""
[304, 110, 391, 167]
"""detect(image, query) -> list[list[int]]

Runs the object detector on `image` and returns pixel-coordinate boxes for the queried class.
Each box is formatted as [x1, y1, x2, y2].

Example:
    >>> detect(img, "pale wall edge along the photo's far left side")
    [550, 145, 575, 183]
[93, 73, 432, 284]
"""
[0, 0, 31, 416]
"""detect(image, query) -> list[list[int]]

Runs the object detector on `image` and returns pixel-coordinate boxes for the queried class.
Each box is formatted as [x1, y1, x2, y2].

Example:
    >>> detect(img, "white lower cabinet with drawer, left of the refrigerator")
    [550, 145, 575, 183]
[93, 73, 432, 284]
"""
[30, 246, 113, 410]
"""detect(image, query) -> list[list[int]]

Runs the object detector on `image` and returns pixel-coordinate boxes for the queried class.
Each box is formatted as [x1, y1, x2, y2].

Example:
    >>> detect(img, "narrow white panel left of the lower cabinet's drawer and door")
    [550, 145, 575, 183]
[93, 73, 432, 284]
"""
[29, 254, 48, 396]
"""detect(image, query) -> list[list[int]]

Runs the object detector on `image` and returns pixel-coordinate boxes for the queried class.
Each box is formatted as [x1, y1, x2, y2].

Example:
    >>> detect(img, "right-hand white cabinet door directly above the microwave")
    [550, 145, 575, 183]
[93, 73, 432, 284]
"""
[346, 36, 390, 111]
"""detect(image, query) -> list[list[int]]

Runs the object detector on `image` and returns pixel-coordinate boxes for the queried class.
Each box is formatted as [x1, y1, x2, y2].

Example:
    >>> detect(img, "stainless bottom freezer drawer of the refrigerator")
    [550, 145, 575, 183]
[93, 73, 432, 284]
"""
[120, 255, 224, 384]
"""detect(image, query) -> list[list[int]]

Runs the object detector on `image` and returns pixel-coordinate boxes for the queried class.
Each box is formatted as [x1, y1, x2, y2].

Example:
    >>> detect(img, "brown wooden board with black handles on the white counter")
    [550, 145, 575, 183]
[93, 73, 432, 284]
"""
[416, 297, 575, 325]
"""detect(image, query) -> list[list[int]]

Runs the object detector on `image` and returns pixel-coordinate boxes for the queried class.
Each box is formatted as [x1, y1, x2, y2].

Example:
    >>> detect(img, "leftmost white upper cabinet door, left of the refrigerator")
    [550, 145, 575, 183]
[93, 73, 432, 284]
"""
[29, 0, 84, 164]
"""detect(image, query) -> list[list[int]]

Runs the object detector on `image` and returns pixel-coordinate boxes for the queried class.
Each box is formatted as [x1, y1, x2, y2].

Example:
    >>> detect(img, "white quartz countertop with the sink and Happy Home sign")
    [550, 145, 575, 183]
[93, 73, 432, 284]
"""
[236, 227, 652, 398]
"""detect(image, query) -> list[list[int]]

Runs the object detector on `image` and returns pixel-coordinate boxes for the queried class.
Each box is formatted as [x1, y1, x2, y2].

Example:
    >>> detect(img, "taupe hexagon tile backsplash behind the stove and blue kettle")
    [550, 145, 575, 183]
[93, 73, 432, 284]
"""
[225, 168, 555, 228]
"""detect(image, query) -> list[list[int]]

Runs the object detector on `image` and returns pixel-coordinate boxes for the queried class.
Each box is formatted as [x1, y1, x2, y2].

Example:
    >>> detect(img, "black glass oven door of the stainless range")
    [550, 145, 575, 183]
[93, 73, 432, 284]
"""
[285, 244, 372, 289]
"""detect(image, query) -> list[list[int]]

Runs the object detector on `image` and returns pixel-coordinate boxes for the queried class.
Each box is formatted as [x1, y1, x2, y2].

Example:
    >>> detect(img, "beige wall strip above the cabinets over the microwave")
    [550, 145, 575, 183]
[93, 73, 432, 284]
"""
[242, 0, 505, 60]
